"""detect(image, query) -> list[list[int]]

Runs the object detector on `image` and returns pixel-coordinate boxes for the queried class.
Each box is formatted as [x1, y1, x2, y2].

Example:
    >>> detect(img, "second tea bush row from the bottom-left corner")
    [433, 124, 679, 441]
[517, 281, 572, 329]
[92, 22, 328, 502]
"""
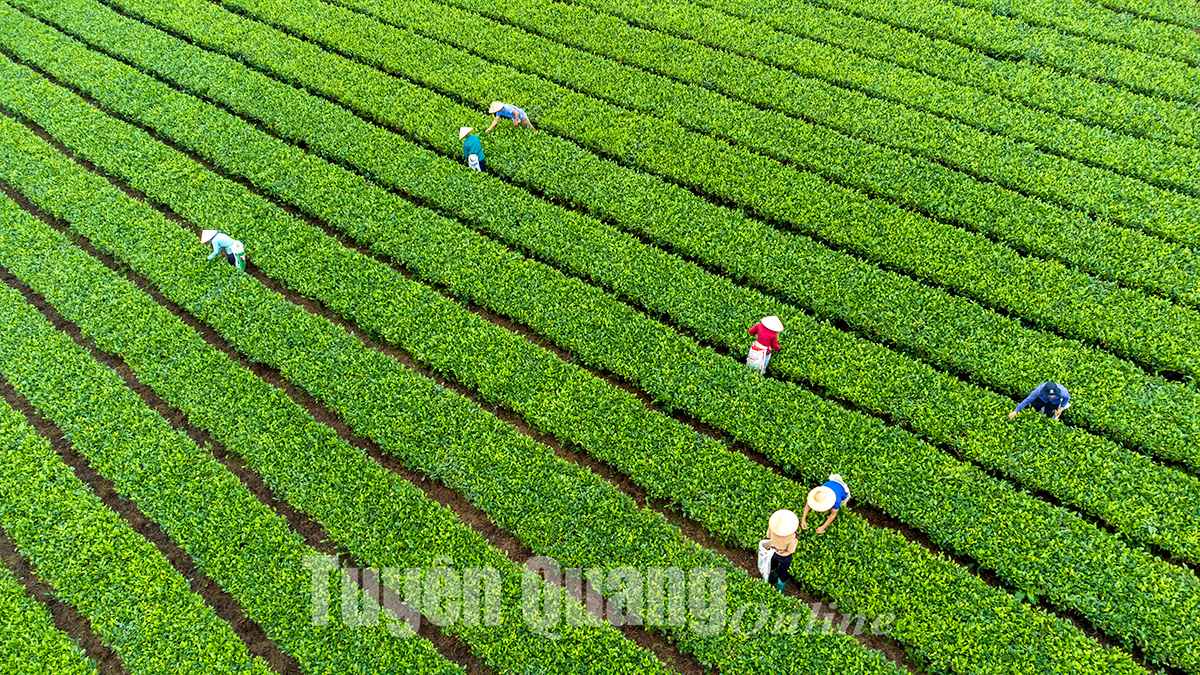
[0, 369, 271, 675]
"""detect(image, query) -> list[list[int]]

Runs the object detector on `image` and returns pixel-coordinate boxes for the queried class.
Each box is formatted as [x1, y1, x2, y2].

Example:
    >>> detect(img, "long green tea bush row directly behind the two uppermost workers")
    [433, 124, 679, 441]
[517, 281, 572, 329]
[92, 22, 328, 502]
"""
[192, 0, 1200, 375]
